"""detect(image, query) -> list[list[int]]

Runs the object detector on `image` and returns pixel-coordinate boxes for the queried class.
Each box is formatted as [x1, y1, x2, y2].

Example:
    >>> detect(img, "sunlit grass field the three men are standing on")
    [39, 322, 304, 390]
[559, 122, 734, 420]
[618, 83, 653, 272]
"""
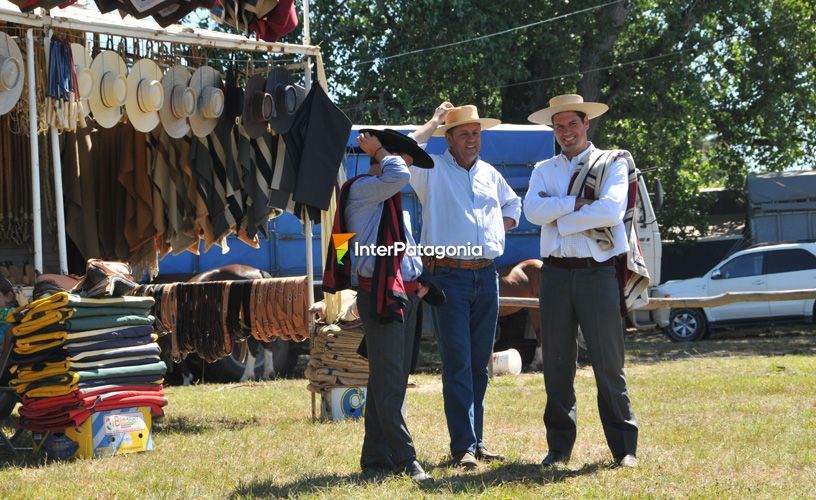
[0, 325, 816, 498]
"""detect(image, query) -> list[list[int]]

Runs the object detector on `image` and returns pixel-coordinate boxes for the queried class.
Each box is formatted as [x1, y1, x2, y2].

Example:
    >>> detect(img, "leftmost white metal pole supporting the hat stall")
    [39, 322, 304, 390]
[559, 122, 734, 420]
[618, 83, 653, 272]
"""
[26, 29, 43, 273]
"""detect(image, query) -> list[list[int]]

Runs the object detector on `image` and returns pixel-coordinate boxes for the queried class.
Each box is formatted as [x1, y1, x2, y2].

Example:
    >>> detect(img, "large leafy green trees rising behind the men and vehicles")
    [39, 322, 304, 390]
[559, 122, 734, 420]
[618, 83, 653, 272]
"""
[311, 0, 816, 238]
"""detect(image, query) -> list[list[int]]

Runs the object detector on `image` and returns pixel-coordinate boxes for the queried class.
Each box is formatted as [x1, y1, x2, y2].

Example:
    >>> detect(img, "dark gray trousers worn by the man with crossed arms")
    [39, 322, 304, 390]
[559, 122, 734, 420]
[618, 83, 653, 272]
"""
[539, 262, 638, 460]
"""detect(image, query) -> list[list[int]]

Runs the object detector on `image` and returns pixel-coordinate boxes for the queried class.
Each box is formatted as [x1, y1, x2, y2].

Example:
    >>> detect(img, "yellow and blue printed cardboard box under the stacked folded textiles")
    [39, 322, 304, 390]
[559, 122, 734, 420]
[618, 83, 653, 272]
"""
[32, 407, 153, 460]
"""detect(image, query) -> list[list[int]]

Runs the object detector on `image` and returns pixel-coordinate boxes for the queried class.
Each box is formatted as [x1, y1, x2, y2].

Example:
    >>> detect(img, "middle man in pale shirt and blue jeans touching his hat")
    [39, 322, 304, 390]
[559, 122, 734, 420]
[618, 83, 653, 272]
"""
[411, 102, 521, 468]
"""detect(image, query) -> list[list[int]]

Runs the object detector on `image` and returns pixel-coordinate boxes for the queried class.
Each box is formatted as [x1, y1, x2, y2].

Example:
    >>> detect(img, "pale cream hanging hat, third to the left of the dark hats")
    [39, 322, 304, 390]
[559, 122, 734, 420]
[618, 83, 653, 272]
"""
[125, 59, 164, 132]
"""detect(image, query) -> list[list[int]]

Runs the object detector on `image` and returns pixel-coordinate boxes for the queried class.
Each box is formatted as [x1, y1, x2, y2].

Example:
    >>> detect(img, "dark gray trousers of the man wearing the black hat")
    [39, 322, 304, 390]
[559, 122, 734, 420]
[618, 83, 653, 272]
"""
[357, 290, 420, 467]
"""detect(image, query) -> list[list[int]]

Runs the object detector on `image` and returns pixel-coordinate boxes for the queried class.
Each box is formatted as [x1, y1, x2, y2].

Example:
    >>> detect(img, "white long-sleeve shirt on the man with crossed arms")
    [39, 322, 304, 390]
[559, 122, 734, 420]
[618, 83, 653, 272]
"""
[524, 143, 629, 262]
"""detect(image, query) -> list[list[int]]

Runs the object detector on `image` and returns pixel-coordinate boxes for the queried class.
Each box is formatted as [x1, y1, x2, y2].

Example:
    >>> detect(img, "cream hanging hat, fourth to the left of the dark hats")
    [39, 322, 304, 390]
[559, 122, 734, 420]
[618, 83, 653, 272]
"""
[88, 50, 127, 128]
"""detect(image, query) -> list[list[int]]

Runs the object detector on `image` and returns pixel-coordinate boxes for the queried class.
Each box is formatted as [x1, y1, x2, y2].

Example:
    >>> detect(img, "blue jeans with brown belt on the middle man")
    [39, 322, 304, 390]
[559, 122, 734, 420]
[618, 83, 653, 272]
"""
[433, 265, 499, 455]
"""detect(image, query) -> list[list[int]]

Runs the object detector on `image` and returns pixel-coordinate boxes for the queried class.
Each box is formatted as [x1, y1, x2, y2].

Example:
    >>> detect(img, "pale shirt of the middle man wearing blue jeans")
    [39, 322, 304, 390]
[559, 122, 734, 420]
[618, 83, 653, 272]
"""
[411, 150, 521, 259]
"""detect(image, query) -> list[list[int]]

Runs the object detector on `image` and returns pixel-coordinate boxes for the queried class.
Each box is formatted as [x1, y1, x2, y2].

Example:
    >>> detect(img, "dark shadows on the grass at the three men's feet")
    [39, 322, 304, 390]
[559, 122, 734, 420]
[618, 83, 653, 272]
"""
[231, 461, 611, 498]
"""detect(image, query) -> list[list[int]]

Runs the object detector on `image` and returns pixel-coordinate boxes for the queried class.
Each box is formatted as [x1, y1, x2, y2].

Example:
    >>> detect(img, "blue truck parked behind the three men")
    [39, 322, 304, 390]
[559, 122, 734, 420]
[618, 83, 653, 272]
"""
[159, 125, 661, 381]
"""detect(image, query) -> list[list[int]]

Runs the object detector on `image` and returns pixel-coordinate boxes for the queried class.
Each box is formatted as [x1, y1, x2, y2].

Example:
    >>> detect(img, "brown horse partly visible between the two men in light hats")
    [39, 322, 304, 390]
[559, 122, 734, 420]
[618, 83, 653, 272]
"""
[499, 259, 543, 370]
